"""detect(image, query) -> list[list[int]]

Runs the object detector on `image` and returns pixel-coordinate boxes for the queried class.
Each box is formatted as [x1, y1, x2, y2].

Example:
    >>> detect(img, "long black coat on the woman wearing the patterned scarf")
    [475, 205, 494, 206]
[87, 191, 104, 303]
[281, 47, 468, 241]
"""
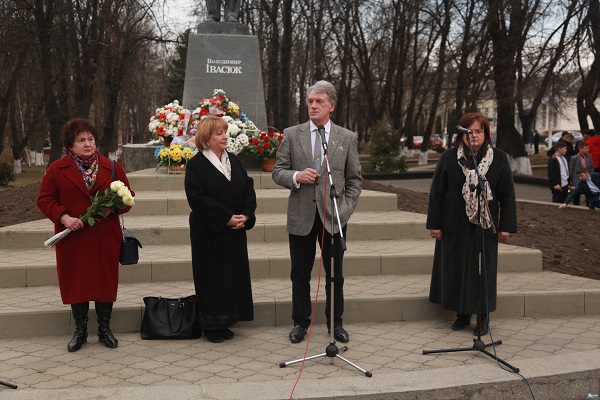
[427, 148, 517, 314]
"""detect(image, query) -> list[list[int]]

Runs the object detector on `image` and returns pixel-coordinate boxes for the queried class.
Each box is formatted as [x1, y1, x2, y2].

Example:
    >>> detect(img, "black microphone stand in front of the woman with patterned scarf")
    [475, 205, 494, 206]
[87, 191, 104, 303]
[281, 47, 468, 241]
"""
[423, 127, 519, 373]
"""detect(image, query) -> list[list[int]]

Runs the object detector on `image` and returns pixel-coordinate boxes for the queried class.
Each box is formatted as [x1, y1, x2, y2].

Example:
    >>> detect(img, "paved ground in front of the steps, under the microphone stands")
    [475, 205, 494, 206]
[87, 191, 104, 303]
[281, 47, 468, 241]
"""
[0, 317, 600, 400]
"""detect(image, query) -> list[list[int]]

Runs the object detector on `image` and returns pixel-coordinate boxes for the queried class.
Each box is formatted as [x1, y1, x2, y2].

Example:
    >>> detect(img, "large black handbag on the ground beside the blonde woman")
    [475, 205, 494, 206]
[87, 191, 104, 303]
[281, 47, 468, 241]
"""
[140, 295, 202, 339]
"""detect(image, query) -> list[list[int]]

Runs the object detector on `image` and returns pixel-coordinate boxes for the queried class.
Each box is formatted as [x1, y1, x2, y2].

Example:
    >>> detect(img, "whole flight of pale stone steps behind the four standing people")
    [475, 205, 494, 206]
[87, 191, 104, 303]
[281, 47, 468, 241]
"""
[0, 169, 600, 338]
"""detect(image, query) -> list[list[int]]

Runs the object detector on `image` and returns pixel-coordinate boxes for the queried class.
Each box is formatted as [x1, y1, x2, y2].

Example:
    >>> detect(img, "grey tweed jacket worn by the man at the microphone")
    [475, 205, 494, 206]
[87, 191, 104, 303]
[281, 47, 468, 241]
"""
[273, 122, 362, 236]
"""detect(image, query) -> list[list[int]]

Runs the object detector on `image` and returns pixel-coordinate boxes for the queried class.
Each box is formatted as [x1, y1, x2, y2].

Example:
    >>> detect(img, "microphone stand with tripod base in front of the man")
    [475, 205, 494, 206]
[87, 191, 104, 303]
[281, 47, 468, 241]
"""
[279, 130, 373, 378]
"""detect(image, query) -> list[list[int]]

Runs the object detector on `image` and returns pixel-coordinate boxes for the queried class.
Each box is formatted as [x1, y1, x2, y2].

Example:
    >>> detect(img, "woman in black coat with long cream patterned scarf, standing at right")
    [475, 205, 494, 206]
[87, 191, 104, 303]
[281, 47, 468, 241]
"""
[427, 113, 517, 335]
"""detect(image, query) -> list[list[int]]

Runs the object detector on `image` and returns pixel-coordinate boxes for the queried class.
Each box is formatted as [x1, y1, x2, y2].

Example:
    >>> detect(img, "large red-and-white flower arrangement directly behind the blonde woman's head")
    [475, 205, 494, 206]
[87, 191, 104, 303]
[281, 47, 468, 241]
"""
[190, 89, 258, 154]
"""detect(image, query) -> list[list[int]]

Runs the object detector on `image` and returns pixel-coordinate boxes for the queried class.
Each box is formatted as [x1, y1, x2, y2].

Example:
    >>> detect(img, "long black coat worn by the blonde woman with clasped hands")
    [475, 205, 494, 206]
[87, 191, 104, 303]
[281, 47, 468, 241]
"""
[185, 153, 256, 329]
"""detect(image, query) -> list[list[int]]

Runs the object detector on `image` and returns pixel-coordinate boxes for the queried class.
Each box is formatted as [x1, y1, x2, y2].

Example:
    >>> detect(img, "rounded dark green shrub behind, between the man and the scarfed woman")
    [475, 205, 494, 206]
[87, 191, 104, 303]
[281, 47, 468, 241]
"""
[365, 120, 408, 172]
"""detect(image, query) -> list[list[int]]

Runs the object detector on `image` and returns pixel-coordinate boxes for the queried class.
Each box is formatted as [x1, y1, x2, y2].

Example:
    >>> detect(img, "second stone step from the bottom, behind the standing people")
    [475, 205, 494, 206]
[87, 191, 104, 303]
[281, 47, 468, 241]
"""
[0, 239, 542, 287]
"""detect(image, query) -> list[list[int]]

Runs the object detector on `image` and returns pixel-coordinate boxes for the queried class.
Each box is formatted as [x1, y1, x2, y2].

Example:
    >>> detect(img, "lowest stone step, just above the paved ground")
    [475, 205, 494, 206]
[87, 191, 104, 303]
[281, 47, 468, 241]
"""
[0, 271, 600, 338]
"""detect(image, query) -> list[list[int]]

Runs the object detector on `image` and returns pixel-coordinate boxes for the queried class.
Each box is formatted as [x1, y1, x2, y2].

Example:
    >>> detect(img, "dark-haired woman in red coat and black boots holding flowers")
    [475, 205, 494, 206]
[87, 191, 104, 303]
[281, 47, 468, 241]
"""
[37, 118, 134, 352]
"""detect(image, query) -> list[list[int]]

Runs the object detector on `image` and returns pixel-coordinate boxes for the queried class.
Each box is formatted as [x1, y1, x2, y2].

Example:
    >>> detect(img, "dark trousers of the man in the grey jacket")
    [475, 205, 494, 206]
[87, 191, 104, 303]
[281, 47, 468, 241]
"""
[289, 212, 346, 328]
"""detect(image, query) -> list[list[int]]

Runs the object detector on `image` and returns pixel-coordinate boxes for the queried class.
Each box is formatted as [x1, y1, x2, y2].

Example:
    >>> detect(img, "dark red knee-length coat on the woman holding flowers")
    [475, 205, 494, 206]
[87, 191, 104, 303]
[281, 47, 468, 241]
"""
[37, 155, 134, 304]
